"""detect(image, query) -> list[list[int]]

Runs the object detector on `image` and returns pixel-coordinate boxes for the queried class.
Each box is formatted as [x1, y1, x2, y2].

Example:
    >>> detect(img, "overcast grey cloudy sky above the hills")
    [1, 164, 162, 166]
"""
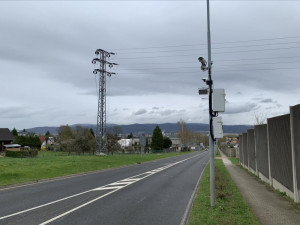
[0, 0, 300, 129]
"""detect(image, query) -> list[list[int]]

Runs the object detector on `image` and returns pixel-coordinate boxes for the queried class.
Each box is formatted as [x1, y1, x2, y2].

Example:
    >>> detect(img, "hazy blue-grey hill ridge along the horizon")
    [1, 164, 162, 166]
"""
[26, 123, 253, 134]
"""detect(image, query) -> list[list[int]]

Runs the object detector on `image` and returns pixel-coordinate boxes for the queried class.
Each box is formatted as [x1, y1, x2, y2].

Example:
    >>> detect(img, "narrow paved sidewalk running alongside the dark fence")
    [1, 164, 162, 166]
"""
[220, 151, 300, 225]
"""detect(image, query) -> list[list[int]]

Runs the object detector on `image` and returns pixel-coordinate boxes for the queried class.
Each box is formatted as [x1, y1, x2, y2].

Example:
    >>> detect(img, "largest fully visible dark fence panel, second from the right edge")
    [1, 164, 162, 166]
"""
[267, 114, 294, 198]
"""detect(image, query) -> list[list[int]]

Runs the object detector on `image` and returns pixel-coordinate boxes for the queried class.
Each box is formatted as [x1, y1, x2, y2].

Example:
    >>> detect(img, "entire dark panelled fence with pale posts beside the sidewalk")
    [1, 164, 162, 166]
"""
[239, 104, 300, 202]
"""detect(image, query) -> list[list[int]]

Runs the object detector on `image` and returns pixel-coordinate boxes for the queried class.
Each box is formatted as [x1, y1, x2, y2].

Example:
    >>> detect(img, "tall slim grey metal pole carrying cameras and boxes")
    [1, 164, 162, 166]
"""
[207, 0, 216, 207]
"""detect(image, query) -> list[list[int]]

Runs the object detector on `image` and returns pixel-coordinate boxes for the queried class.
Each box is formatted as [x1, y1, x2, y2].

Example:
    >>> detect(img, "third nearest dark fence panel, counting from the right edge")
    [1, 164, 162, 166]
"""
[254, 124, 269, 179]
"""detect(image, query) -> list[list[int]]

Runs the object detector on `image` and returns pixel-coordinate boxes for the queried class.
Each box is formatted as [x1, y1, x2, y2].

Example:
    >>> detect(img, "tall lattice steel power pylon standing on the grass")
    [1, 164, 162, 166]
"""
[92, 49, 118, 154]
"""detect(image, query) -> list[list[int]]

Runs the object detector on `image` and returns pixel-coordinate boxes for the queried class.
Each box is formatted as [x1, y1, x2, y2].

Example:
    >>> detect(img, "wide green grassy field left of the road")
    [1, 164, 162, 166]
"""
[0, 152, 186, 186]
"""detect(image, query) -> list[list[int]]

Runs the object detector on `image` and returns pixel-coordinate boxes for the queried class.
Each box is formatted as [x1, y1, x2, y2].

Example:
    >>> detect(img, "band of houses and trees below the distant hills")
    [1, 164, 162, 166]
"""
[0, 124, 238, 158]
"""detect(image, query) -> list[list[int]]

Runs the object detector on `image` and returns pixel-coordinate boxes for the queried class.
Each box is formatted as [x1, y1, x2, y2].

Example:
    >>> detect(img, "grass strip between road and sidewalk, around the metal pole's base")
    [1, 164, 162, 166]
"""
[188, 159, 260, 225]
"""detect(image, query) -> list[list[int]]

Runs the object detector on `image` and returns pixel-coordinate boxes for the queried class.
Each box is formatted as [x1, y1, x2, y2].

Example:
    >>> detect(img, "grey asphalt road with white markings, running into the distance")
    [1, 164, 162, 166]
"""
[0, 152, 208, 225]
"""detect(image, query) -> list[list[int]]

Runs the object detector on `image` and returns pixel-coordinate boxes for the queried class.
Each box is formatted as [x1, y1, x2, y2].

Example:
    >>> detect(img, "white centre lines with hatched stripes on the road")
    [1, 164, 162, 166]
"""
[0, 155, 199, 225]
